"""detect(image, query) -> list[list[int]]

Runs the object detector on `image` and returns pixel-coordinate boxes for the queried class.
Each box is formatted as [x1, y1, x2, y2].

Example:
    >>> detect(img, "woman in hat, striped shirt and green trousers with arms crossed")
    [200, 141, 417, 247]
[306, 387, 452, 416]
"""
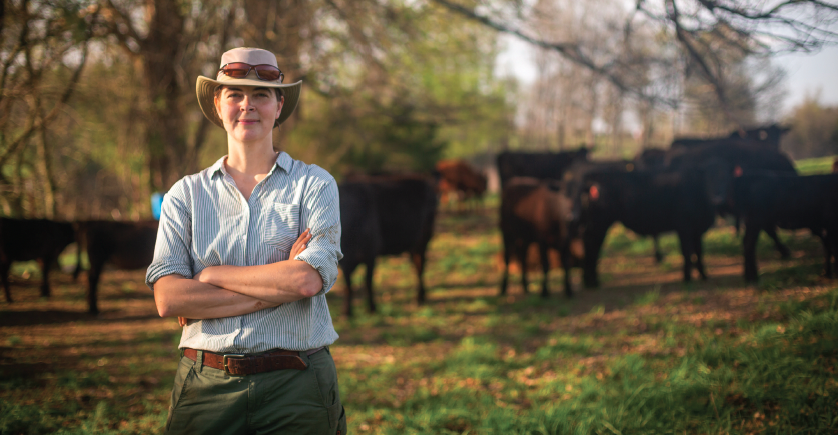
[146, 48, 346, 435]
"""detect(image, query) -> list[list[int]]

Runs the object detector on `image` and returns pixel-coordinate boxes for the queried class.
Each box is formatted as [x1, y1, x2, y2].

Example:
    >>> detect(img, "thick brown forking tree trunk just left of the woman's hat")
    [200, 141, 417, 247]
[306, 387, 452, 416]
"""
[98, 0, 236, 190]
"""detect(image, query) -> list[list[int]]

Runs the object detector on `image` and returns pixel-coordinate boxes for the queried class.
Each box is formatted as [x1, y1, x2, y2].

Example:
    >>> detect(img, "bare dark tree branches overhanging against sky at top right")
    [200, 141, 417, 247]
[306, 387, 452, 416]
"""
[434, 0, 838, 129]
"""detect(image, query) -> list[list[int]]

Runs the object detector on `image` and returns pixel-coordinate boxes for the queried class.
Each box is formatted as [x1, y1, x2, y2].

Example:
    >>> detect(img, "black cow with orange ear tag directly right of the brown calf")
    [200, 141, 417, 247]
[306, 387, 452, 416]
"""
[571, 169, 715, 287]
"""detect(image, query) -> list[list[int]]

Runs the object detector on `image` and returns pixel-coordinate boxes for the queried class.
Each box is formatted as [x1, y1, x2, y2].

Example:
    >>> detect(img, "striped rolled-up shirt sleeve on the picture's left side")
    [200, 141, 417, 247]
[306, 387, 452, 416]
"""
[145, 180, 192, 290]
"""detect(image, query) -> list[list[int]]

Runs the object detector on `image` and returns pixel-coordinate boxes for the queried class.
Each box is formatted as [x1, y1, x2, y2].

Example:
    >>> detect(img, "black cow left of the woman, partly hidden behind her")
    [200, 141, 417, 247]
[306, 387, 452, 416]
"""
[73, 221, 158, 314]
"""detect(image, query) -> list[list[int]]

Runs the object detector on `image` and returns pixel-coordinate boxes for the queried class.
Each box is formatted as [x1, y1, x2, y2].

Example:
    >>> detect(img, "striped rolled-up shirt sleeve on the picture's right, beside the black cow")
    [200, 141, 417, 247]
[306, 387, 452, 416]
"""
[294, 170, 343, 295]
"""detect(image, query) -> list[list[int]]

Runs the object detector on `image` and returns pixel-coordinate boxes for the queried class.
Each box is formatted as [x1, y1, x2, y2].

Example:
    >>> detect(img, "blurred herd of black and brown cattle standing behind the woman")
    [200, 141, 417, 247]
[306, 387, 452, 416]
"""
[0, 125, 838, 316]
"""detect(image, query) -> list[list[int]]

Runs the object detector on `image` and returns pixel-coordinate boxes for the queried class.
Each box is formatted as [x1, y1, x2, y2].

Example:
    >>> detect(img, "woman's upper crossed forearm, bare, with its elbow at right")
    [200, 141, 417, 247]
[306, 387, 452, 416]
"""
[196, 260, 323, 304]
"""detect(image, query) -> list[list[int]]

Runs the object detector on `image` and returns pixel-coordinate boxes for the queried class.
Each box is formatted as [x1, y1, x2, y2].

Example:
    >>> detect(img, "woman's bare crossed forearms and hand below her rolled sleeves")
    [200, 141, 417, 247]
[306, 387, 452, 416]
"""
[154, 229, 323, 326]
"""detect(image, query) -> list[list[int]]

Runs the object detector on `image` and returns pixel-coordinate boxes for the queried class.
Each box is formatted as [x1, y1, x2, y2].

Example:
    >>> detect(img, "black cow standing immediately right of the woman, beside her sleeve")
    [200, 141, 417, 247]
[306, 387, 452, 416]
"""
[338, 175, 437, 316]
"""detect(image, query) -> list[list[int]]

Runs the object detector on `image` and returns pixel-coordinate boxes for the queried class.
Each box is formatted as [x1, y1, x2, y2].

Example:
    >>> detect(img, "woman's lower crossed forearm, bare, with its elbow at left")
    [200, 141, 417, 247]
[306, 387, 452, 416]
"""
[154, 275, 280, 319]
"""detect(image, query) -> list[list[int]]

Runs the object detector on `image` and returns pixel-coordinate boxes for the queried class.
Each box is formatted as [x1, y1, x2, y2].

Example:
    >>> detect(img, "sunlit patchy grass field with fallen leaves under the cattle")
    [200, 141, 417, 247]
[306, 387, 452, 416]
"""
[0, 204, 838, 434]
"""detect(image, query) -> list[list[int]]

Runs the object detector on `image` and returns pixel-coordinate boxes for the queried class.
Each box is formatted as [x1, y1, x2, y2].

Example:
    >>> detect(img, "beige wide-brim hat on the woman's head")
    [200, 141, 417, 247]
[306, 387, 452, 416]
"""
[195, 47, 303, 128]
